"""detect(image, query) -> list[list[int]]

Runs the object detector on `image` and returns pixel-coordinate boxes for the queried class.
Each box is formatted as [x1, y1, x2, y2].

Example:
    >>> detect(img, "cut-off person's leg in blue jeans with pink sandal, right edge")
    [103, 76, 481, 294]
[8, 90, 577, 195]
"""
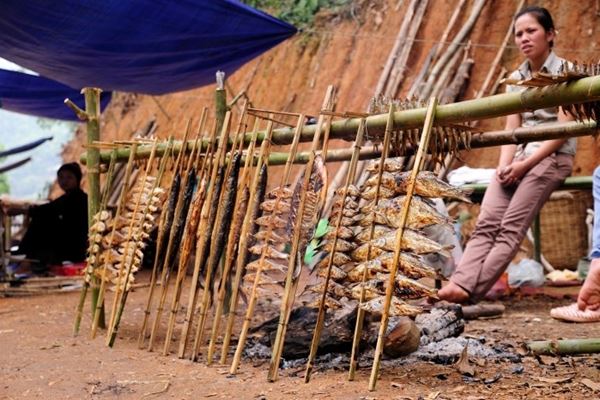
[550, 167, 600, 322]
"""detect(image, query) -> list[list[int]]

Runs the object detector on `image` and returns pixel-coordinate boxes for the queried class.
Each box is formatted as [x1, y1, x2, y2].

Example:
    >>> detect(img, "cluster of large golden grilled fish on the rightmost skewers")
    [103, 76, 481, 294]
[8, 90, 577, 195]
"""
[308, 158, 470, 316]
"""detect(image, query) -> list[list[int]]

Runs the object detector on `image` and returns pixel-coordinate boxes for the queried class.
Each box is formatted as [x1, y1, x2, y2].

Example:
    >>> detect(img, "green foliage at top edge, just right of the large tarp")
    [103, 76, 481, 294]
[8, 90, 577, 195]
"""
[244, 0, 352, 28]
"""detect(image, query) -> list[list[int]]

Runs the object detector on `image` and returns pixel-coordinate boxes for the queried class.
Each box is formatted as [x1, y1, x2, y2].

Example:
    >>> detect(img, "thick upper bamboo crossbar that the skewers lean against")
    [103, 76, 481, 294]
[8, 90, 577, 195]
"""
[80, 76, 600, 164]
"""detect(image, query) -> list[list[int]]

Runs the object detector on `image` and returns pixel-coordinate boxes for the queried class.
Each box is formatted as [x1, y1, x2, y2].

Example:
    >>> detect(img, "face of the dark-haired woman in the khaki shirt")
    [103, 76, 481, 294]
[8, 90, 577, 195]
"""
[515, 14, 555, 60]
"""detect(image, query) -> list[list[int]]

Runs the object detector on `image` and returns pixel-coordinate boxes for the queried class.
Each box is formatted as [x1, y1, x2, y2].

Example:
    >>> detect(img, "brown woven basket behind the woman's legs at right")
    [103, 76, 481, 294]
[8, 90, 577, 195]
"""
[540, 190, 593, 270]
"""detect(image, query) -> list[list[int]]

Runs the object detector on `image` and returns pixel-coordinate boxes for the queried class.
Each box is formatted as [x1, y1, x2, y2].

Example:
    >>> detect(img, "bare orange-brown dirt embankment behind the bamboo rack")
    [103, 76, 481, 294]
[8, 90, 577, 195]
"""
[65, 0, 600, 175]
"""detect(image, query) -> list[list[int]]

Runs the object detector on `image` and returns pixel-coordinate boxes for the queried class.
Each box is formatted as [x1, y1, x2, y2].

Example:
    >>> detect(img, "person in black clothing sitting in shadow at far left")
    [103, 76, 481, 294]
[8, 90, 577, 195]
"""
[3, 162, 88, 273]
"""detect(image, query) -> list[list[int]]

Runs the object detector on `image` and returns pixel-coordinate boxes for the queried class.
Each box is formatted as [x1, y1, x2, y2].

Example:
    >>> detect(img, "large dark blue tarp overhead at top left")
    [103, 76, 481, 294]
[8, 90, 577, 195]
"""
[0, 0, 296, 94]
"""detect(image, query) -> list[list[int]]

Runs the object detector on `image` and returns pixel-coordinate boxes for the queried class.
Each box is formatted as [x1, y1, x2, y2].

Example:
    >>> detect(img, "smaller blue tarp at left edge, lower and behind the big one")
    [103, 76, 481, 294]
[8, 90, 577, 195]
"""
[0, 69, 111, 121]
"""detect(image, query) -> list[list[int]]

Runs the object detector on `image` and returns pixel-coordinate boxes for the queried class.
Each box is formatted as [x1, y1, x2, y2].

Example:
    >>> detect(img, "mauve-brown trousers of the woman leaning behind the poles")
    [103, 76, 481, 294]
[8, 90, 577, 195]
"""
[450, 153, 573, 301]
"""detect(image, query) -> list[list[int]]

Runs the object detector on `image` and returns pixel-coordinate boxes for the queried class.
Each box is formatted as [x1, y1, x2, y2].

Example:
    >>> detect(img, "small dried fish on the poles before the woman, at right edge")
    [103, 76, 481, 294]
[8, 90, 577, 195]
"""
[503, 61, 600, 122]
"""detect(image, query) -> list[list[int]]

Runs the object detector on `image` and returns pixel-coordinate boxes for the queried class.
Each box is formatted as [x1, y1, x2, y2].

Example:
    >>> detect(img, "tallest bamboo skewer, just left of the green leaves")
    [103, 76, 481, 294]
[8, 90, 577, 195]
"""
[267, 86, 334, 382]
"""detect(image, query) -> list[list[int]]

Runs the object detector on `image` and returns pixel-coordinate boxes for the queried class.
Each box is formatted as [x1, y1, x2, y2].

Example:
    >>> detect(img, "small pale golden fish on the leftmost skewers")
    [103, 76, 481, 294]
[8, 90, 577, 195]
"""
[86, 176, 165, 290]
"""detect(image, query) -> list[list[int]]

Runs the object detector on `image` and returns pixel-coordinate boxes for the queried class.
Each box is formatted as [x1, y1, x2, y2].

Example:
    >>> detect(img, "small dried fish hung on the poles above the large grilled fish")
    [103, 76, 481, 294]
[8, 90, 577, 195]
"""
[365, 96, 472, 162]
